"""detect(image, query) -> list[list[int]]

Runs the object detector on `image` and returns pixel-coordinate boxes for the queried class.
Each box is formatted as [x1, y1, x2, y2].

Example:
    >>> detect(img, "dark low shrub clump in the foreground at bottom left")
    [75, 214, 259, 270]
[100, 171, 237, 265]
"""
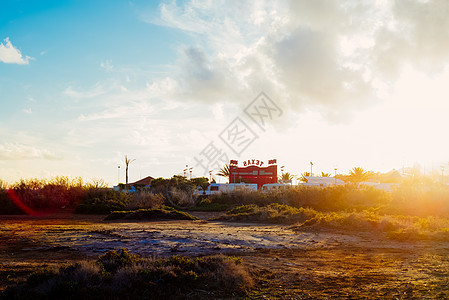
[0, 249, 253, 300]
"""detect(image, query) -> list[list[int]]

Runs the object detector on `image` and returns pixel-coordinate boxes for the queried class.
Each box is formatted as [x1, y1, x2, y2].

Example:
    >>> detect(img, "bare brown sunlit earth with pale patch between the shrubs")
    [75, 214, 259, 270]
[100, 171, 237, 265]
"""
[0, 213, 449, 299]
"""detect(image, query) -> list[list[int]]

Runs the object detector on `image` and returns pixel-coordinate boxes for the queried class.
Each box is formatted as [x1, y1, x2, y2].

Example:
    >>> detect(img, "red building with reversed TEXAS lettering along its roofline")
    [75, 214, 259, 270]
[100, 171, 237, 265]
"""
[229, 160, 278, 189]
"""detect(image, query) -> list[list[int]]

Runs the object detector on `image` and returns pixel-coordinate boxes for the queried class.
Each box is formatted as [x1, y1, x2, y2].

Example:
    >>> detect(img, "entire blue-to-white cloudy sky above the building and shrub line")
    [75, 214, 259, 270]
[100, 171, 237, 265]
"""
[0, 0, 449, 185]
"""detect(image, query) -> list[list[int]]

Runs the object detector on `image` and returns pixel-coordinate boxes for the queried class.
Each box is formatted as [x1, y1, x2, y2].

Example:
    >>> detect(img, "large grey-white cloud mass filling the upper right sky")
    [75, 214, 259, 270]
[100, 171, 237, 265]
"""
[145, 0, 449, 122]
